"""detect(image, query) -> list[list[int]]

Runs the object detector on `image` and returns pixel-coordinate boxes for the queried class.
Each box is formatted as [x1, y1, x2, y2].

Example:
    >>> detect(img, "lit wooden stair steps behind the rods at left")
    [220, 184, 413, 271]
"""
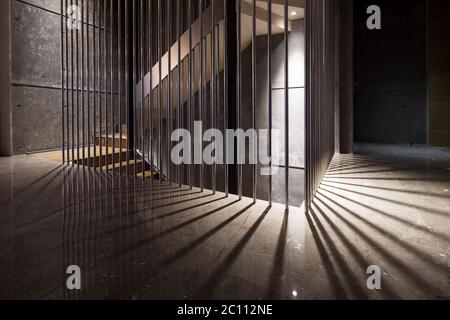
[74, 128, 159, 180]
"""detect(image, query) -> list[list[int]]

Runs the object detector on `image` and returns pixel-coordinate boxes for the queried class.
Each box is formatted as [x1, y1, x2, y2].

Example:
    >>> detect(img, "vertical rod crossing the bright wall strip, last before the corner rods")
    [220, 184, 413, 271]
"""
[284, 0, 289, 210]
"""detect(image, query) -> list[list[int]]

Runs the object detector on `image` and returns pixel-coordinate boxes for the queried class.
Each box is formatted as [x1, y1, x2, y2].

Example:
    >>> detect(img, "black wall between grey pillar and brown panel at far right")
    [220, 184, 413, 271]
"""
[354, 0, 427, 144]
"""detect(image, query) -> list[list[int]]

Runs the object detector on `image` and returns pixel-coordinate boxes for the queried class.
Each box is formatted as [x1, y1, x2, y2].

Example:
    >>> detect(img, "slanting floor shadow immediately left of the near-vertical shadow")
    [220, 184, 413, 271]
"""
[194, 207, 271, 297]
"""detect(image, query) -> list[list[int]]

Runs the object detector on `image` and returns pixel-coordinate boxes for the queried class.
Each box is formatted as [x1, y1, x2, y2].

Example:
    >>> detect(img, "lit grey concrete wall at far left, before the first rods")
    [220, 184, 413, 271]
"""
[11, 0, 61, 154]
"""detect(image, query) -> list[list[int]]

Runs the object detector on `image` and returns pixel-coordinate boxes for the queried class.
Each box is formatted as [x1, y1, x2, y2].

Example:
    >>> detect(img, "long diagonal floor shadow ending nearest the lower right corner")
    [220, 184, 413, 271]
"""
[316, 191, 439, 295]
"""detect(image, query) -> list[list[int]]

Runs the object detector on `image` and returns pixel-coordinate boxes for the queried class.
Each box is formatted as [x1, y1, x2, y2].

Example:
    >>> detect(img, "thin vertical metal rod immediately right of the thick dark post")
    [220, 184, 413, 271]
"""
[236, 0, 242, 200]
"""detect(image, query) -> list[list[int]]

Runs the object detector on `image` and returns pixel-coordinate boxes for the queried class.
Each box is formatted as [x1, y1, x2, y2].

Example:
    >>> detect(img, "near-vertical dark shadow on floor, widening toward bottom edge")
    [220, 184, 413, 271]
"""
[265, 210, 289, 299]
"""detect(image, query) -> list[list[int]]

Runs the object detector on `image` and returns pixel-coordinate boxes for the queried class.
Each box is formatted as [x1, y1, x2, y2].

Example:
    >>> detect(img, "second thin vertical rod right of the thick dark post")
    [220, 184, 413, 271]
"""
[251, 0, 258, 202]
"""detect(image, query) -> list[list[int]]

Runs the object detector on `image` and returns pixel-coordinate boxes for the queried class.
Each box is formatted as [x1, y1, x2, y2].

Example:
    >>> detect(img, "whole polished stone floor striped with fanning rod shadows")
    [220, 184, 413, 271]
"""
[0, 150, 450, 299]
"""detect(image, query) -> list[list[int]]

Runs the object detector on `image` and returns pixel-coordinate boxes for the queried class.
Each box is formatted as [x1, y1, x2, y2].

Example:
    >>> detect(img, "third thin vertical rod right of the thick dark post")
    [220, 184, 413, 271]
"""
[267, 0, 273, 206]
